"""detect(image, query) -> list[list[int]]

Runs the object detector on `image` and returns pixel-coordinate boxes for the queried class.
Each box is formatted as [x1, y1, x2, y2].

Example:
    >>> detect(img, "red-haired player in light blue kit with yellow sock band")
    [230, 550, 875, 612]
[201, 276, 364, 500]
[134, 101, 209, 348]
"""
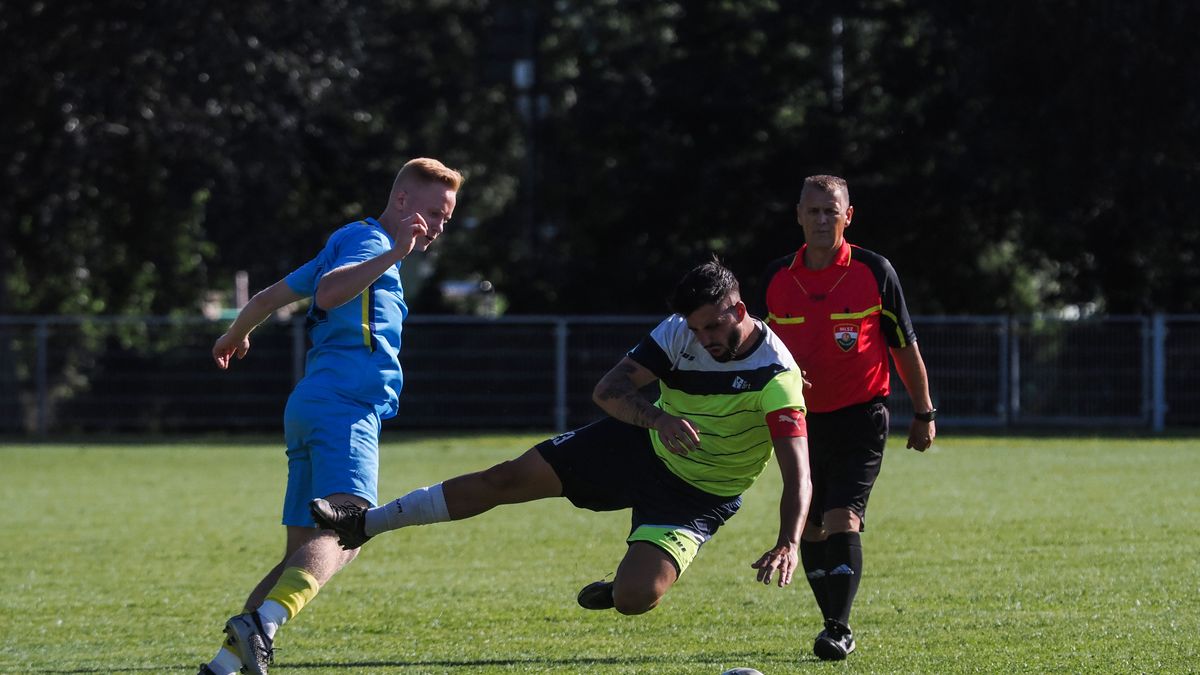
[199, 157, 463, 675]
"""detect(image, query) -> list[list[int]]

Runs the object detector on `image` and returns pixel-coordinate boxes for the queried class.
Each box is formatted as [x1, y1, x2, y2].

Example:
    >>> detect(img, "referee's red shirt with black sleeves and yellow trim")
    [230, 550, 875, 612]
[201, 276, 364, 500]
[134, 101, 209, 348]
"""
[767, 241, 917, 412]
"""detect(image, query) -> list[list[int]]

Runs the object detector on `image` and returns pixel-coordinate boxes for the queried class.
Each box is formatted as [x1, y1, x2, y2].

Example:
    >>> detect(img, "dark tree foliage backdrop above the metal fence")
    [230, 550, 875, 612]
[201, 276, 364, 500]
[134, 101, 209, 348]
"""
[0, 0, 1200, 313]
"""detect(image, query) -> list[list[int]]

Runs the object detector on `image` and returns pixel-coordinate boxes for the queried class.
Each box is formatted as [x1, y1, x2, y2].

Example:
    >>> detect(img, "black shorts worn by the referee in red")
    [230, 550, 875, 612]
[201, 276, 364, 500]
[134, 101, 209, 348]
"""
[805, 398, 889, 530]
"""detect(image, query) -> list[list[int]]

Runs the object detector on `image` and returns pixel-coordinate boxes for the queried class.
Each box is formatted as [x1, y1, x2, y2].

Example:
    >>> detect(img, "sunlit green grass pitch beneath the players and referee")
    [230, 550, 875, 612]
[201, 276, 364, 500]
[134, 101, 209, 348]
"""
[0, 432, 1200, 675]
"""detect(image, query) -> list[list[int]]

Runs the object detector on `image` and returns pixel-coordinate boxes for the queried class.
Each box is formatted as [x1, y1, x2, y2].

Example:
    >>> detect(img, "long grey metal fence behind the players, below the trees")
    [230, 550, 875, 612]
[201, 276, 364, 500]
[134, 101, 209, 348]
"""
[0, 315, 1200, 435]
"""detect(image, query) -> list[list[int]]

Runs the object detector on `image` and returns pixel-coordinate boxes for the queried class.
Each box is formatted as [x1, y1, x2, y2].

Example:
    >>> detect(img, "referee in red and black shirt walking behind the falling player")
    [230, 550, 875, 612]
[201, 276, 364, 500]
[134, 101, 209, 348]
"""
[766, 175, 937, 661]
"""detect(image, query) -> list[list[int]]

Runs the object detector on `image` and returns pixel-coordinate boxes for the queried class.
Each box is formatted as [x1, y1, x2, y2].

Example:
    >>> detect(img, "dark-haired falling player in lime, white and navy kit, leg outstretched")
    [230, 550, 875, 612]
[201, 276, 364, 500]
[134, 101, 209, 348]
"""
[311, 261, 811, 614]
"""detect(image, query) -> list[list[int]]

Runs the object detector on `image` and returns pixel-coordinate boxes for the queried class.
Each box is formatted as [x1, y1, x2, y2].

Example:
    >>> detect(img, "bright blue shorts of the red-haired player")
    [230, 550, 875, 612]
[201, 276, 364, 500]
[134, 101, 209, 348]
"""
[283, 396, 382, 527]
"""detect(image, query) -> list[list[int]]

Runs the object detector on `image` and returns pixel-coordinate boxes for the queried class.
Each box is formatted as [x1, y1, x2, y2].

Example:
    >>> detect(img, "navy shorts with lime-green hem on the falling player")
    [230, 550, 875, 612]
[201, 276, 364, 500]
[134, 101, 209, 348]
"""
[536, 417, 742, 573]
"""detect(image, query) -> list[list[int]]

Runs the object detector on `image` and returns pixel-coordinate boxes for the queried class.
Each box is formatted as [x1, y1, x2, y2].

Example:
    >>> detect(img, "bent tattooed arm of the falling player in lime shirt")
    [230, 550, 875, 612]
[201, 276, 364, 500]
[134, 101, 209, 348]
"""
[592, 357, 700, 455]
